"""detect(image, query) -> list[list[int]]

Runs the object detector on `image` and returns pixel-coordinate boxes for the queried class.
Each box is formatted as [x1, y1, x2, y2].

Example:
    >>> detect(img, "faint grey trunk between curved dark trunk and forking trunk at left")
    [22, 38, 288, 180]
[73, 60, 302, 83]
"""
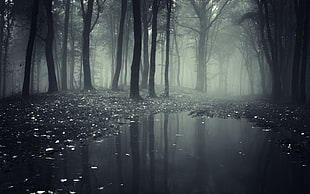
[61, 0, 71, 90]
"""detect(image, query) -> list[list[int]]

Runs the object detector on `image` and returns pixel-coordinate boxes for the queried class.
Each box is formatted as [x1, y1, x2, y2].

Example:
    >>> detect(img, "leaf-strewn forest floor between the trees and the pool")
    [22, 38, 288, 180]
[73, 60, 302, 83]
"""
[0, 89, 310, 172]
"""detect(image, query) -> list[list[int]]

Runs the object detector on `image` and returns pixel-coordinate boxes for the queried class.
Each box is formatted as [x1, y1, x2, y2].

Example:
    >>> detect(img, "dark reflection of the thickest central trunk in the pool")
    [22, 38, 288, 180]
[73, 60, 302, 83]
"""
[130, 117, 140, 194]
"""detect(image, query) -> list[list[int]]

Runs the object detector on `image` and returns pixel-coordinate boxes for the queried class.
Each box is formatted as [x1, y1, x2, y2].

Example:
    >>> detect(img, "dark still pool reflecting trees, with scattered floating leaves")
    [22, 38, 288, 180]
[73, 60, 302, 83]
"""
[0, 113, 310, 194]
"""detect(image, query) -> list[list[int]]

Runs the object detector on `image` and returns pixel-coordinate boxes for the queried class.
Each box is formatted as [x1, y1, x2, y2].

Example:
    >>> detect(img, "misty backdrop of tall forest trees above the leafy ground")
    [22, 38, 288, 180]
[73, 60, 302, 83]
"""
[0, 0, 310, 104]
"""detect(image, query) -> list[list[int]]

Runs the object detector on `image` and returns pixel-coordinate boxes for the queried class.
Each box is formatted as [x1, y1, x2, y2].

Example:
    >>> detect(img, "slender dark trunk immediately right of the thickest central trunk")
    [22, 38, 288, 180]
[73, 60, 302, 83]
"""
[149, 0, 158, 97]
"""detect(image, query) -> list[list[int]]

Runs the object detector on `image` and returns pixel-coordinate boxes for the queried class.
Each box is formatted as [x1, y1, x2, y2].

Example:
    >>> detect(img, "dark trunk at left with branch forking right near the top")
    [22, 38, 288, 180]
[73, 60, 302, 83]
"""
[81, 0, 94, 90]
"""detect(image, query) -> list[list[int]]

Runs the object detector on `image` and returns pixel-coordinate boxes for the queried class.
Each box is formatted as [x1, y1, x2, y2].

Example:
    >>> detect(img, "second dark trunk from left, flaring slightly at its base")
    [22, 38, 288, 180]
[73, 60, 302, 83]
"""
[44, 0, 58, 93]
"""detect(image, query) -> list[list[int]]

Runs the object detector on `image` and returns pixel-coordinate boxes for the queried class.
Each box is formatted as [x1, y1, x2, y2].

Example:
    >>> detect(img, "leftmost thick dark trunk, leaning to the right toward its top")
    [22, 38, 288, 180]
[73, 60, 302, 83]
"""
[22, 0, 39, 96]
